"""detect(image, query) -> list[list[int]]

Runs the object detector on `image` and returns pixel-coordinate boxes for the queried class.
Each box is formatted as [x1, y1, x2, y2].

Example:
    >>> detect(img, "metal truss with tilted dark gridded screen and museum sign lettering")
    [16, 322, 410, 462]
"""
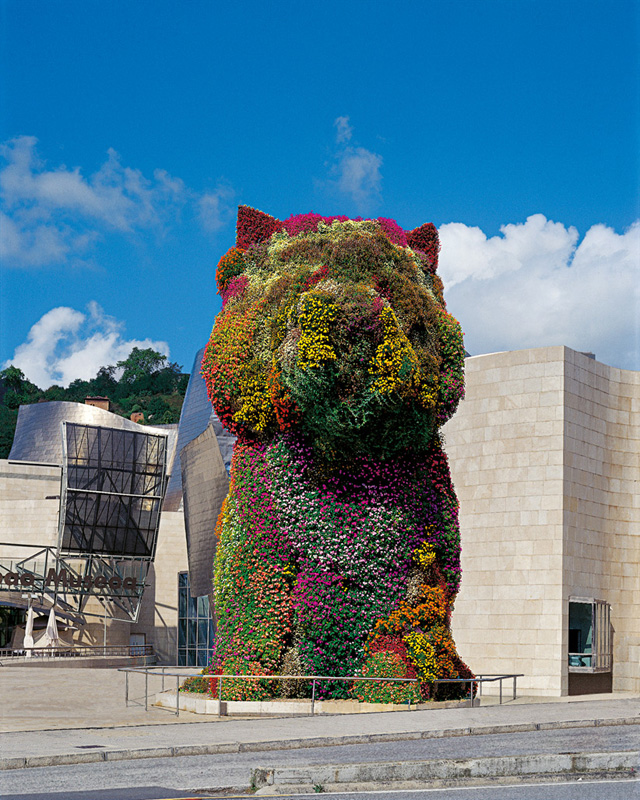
[0, 420, 167, 622]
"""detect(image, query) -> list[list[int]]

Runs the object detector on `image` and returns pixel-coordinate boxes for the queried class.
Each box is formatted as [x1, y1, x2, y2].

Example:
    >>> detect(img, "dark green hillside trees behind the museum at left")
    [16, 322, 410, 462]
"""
[0, 347, 189, 458]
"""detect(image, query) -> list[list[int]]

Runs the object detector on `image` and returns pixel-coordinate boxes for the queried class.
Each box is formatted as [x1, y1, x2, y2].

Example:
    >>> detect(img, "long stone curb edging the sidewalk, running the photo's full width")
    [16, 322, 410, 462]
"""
[0, 717, 640, 770]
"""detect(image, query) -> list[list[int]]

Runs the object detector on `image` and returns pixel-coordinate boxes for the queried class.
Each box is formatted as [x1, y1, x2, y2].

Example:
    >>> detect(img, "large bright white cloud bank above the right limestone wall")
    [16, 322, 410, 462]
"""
[438, 214, 640, 369]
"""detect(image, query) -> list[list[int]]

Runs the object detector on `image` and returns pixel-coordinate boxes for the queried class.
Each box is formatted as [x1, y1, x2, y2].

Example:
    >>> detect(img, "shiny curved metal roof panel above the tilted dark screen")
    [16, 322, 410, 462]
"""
[9, 400, 177, 465]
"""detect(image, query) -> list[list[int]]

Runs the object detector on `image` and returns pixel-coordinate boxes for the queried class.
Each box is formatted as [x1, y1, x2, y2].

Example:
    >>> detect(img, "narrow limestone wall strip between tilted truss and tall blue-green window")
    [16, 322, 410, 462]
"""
[131, 511, 188, 664]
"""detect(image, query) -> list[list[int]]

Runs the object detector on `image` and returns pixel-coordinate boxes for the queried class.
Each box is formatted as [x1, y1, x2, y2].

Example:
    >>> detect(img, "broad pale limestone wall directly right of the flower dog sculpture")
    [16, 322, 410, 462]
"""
[444, 348, 563, 695]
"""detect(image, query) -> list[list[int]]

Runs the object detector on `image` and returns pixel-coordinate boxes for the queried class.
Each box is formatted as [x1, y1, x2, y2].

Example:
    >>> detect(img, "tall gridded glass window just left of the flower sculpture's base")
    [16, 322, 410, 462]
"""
[178, 572, 214, 667]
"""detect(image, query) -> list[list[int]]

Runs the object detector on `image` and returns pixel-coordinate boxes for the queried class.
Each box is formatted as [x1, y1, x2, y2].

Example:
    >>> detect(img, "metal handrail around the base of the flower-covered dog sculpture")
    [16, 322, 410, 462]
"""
[118, 667, 524, 717]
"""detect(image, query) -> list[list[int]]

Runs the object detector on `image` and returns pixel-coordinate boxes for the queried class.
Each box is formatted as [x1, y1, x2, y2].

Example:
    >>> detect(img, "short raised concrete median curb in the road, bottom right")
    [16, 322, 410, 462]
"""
[252, 750, 640, 795]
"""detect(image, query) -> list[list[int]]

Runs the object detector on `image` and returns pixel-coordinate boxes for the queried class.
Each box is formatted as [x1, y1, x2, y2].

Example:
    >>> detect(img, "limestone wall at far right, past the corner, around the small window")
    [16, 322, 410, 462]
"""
[563, 349, 640, 692]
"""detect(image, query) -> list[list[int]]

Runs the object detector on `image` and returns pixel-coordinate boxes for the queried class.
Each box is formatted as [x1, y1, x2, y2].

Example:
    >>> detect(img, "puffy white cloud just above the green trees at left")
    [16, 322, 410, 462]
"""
[3, 302, 169, 389]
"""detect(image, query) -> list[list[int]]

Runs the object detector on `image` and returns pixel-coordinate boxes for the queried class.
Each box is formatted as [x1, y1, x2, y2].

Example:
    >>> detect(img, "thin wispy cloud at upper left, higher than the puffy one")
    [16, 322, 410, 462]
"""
[0, 136, 235, 266]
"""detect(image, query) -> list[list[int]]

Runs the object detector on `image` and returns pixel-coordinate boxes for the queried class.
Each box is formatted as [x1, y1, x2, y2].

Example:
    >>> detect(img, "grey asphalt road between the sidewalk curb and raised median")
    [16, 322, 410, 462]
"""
[0, 725, 640, 800]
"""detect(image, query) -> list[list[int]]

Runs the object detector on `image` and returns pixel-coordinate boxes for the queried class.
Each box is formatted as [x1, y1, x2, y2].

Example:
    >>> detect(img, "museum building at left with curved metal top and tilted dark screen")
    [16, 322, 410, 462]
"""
[0, 402, 177, 656]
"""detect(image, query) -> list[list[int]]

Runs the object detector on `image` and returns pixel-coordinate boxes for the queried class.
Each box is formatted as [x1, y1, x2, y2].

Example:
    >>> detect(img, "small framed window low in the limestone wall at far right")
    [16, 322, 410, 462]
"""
[569, 597, 612, 672]
